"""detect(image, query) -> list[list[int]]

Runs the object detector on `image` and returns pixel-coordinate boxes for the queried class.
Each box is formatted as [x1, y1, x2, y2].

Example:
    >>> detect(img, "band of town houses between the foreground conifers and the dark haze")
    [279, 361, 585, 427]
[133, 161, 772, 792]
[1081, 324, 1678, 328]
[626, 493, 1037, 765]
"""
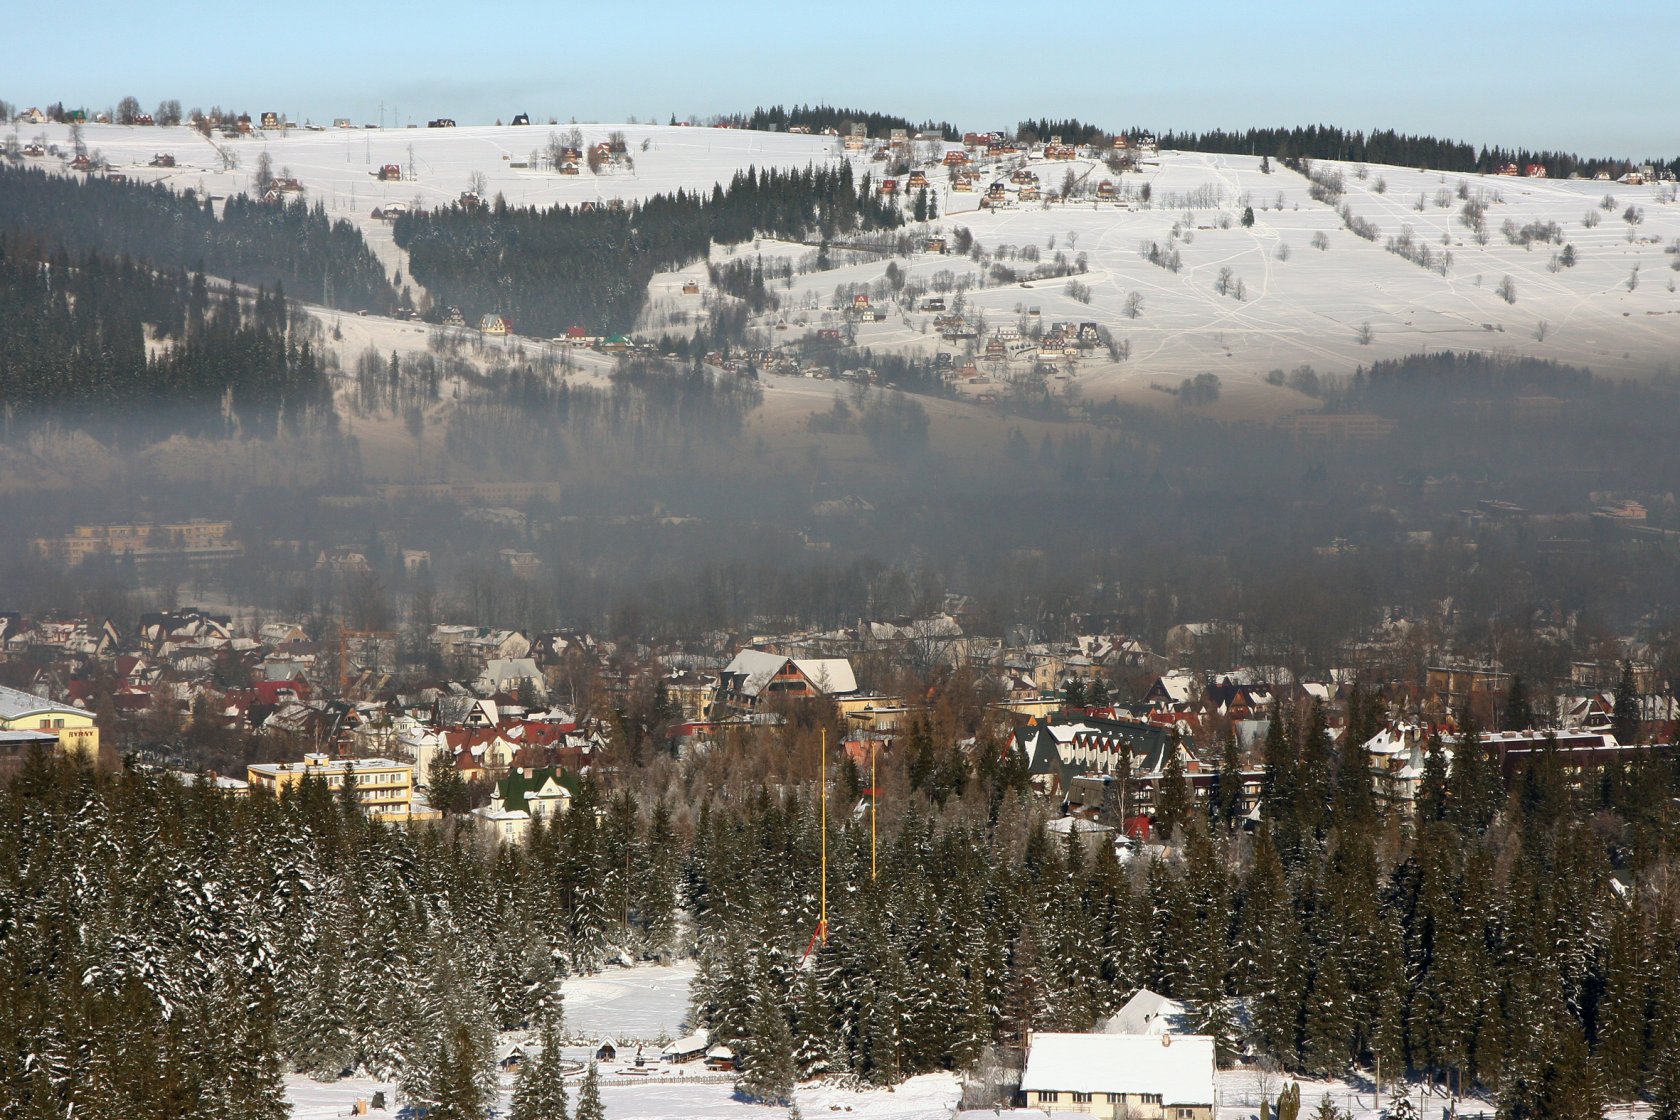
[0, 596, 1680, 843]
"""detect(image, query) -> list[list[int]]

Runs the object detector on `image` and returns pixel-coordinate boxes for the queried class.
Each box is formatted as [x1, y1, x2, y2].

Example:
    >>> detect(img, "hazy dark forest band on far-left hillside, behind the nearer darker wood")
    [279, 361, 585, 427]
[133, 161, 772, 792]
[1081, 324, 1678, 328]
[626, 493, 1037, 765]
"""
[0, 165, 396, 311]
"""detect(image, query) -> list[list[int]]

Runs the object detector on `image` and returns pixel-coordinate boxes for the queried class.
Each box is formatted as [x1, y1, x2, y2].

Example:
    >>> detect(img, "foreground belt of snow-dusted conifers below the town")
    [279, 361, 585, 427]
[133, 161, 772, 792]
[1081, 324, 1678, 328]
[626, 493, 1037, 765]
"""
[0, 693, 1680, 1117]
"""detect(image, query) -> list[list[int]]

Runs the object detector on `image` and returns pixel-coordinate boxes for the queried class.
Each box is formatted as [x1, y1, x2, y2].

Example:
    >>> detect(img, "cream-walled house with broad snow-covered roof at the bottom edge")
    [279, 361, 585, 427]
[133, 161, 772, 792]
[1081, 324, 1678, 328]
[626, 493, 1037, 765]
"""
[1021, 1031, 1216, 1120]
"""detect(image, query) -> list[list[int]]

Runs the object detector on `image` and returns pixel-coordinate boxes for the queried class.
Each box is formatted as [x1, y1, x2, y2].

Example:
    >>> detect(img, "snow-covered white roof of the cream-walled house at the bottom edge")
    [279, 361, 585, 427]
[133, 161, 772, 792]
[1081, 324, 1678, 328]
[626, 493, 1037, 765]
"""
[1021, 1034, 1213, 1107]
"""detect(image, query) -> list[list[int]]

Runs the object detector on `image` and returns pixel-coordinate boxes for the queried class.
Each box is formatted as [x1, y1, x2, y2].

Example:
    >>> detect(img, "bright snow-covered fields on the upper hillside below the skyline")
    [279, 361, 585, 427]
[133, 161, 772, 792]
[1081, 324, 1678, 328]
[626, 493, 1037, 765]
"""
[18, 124, 1680, 404]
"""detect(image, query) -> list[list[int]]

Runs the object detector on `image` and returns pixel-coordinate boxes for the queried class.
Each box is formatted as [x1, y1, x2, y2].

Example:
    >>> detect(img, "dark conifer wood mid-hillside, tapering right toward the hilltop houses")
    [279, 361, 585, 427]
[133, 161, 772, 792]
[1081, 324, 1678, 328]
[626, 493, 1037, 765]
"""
[395, 163, 904, 334]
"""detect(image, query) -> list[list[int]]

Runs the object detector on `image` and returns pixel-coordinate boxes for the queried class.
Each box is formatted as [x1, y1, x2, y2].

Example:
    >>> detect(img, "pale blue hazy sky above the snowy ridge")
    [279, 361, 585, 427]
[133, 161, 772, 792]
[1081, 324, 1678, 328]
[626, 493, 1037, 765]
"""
[13, 0, 1680, 156]
